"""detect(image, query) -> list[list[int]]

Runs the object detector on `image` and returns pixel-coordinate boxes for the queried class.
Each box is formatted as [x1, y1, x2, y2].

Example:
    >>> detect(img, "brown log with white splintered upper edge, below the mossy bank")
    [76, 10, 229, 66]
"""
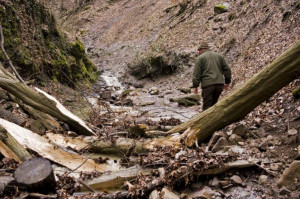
[0, 63, 95, 135]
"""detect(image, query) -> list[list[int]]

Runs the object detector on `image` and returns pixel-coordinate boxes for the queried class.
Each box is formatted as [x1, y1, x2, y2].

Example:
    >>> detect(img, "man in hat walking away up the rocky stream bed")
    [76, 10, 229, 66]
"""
[192, 42, 231, 110]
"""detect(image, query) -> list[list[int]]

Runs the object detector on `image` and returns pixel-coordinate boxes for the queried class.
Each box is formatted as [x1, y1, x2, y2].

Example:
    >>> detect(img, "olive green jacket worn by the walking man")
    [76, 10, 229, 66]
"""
[192, 50, 231, 88]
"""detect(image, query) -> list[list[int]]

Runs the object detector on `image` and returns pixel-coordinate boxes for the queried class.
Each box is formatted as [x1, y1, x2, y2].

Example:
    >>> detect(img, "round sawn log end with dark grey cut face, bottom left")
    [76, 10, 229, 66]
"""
[14, 158, 55, 193]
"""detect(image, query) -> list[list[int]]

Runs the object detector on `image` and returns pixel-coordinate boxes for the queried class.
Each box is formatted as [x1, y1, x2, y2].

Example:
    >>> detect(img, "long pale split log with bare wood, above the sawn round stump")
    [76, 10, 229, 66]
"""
[0, 118, 110, 173]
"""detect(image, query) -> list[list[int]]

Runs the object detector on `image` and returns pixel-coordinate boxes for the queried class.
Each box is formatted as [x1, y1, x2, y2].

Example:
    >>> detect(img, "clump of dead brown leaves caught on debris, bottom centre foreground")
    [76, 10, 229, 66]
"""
[130, 147, 236, 196]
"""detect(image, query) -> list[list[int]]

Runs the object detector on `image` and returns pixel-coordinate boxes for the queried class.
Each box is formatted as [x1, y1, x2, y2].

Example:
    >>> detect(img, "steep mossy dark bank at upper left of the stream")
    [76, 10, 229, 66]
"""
[0, 0, 97, 85]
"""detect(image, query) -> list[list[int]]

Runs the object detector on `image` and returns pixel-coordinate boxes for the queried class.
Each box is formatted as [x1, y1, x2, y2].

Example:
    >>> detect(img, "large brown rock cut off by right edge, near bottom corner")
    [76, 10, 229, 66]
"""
[277, 161, 300, 186]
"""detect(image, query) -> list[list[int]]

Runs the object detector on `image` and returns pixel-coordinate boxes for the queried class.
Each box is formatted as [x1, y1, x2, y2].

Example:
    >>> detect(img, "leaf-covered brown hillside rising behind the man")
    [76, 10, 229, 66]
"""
[48, 0, 300, 85]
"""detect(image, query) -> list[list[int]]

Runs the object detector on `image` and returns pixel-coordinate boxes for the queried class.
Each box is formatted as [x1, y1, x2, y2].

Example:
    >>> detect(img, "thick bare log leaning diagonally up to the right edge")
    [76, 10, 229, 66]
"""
[168, 40, 300, 146]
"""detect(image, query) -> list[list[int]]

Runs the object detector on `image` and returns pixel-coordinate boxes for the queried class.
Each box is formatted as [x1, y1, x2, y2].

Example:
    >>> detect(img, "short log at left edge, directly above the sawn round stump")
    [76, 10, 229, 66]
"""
[0, 125, 32, 163]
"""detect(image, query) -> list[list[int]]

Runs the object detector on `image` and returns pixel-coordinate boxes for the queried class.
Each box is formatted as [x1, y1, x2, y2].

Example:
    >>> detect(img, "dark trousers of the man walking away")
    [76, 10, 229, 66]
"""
[202, 84, 224, 111]
